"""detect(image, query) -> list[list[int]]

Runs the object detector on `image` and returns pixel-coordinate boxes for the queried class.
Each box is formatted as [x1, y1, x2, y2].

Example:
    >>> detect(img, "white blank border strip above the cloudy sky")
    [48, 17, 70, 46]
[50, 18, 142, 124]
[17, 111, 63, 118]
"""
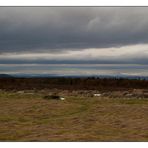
[0, 0, 148, 6]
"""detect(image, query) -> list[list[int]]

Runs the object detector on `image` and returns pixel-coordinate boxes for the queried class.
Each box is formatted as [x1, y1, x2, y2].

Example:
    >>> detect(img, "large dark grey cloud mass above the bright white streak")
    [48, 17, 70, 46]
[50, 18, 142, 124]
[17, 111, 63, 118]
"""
[0, 7, 148, 53]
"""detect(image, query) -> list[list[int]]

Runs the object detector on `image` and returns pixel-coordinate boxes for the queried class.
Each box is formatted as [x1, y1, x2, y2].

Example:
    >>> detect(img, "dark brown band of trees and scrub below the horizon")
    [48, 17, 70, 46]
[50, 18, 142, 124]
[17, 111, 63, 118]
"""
[0, 77, 148, 91]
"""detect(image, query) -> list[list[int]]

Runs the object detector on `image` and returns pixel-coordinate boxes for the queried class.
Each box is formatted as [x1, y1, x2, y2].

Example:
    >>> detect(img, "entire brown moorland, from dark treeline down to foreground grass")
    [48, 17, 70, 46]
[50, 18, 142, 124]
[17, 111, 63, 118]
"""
[0, 77, 148, 141]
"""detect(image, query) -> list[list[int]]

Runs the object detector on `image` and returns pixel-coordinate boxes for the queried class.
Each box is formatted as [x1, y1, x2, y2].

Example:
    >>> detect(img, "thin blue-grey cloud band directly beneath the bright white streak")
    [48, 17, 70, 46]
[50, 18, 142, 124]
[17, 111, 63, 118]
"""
[0, 57, 148, 64]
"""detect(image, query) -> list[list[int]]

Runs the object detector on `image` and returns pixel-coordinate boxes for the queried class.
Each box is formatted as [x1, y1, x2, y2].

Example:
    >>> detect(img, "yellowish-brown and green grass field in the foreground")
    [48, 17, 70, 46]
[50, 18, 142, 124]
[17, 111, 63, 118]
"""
[0, 90, 148, 141]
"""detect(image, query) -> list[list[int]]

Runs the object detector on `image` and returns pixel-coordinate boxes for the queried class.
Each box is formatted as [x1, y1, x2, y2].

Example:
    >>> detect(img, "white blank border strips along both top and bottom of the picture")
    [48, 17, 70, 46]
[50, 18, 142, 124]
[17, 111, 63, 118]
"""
[0, 0, 148, 148]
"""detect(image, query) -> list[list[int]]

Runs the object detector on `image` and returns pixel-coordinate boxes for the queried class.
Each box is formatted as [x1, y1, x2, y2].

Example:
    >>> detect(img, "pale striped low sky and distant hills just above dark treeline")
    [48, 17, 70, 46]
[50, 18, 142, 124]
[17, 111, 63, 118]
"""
[0, 64, 148, 79]
